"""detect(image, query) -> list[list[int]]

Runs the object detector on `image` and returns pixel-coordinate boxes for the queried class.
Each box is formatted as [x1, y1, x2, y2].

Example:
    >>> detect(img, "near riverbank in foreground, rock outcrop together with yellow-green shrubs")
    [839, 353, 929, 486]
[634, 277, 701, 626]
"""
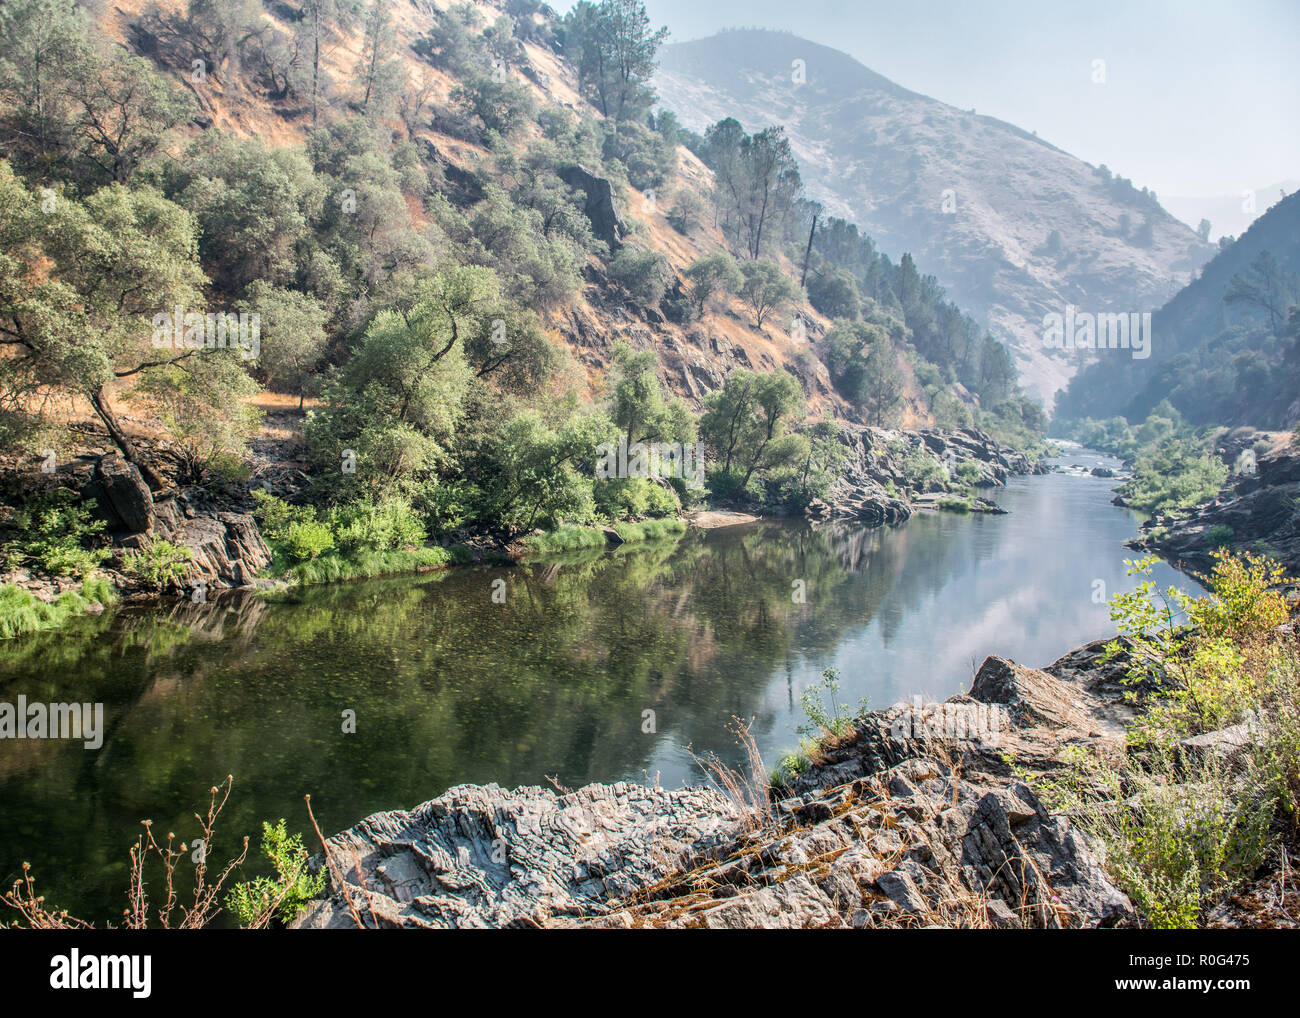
[295, 546, 1300, 928]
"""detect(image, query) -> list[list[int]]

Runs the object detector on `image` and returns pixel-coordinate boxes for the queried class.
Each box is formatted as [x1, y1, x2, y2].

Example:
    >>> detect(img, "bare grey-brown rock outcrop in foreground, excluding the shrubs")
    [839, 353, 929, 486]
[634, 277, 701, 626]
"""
[295, 642, 1134, 928]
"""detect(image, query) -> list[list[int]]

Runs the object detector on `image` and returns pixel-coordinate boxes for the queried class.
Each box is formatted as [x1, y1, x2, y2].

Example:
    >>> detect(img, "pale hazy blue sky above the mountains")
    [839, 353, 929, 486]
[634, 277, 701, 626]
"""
[553, 0, 1300, 196]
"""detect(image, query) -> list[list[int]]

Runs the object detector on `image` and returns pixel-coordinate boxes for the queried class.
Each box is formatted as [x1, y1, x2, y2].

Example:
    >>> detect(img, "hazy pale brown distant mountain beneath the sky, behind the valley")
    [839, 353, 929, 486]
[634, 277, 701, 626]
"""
[655, 30, 1213, 404]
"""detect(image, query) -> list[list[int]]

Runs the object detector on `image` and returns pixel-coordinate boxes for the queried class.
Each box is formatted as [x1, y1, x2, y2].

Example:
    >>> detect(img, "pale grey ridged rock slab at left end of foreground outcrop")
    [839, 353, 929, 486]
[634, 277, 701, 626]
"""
[295, 783, 740, 928]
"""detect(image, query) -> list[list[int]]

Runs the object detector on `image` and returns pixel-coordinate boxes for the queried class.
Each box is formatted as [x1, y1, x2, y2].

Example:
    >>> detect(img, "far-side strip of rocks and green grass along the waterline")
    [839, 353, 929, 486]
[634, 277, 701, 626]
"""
[0, 425, 1045, 634]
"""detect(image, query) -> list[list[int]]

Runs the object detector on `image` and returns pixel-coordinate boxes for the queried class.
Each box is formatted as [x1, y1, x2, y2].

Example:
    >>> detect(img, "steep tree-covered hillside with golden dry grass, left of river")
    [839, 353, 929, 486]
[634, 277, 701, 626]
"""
[0, 0, 1043, 590]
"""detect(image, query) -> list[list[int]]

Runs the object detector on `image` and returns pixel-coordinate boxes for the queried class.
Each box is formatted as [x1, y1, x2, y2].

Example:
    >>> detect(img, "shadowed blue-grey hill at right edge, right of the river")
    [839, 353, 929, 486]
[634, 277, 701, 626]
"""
[1056, 194, 1300, 429]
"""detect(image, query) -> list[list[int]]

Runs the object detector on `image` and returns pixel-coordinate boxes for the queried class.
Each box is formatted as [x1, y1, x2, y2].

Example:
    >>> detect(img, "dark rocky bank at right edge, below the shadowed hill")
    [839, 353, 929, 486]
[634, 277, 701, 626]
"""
[1131, 446, 1300, 576]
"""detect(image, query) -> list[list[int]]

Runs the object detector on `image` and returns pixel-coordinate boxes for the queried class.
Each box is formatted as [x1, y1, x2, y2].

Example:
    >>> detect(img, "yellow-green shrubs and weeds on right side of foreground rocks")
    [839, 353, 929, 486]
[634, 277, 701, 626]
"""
[1040, 554, 1300, 928]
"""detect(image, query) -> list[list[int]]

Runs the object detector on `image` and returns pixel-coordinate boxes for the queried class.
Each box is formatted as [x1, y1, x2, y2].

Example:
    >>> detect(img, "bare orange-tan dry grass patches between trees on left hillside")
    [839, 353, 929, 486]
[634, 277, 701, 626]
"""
[105, 0, 931, 426]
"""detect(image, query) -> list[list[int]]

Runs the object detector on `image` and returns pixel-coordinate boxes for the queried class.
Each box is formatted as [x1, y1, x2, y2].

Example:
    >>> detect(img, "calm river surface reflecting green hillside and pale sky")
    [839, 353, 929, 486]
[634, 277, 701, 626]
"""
[0, 451, 1190, 920]
